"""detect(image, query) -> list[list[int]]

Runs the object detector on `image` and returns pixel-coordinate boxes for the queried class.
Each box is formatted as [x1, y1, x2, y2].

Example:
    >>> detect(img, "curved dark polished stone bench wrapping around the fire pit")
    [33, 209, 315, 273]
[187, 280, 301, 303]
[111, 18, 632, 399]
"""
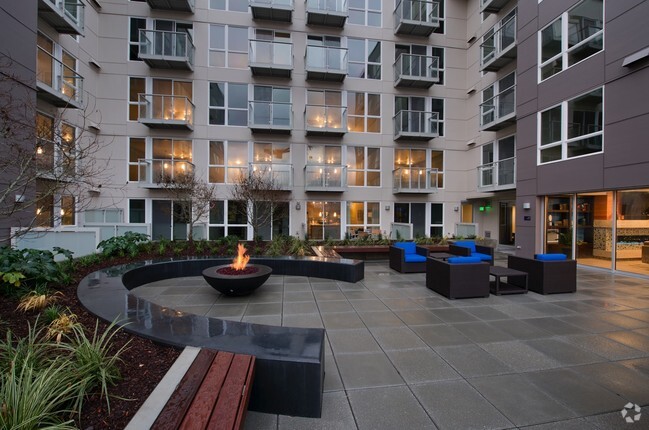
[77, 257, 365, 418]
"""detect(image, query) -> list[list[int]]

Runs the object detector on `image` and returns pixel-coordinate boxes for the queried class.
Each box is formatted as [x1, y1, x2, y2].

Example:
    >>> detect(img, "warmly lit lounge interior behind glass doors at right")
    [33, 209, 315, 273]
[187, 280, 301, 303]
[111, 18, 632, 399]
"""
[544, 189, 649, 275]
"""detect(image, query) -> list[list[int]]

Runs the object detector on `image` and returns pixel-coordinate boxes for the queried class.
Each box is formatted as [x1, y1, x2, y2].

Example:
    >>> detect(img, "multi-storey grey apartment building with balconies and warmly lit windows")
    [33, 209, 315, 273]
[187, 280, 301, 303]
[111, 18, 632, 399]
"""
[5, 0, 649, 276]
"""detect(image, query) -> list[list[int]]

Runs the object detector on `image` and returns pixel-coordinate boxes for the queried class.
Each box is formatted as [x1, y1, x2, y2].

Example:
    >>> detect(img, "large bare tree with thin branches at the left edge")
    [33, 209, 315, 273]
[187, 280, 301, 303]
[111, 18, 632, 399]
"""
[0, 56, 108, 241]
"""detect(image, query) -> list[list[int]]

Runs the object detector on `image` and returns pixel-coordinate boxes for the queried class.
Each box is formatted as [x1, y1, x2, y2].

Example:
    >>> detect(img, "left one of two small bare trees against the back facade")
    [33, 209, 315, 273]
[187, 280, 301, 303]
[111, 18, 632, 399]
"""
[158, 170, 216, 242]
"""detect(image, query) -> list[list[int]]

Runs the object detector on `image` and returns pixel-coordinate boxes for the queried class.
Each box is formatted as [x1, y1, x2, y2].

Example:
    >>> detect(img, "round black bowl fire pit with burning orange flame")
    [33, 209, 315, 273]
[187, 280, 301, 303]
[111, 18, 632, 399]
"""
[203, 244, 273, 296]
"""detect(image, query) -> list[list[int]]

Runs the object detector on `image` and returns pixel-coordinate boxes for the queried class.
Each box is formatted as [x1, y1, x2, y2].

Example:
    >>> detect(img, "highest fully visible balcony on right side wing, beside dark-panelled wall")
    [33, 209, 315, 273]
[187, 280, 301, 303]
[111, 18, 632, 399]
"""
[480, 15, 517, 72]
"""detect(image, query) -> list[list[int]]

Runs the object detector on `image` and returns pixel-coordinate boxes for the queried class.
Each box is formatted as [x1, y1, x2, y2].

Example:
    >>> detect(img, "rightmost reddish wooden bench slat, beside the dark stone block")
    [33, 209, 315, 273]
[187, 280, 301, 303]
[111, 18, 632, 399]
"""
[208, 355, 254, 430]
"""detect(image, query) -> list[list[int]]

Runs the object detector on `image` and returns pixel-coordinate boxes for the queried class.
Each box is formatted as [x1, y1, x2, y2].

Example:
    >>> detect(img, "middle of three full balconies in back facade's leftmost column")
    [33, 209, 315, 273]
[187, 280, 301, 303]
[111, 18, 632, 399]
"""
[138, 94, 194, 131]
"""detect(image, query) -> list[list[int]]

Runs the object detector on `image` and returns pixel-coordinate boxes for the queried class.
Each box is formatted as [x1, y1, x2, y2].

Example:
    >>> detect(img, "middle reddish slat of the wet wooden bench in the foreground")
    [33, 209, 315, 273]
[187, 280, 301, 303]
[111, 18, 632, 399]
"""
[180, 351, 234, 430]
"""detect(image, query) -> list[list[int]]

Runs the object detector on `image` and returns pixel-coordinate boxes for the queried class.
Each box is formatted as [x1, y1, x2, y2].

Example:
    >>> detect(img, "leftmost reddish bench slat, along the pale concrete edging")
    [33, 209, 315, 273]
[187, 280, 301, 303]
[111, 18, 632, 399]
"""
[152, 349, 216, 430]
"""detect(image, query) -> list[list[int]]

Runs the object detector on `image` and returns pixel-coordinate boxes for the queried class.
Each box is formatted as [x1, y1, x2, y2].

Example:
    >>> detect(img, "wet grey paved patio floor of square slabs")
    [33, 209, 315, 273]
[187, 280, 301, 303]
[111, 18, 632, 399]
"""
[132, 256, 649, 430]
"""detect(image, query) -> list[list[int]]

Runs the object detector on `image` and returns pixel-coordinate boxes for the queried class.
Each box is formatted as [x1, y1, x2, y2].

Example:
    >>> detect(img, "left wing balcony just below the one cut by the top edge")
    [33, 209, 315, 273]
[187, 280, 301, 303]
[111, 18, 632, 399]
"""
[36, 47, 83, 109]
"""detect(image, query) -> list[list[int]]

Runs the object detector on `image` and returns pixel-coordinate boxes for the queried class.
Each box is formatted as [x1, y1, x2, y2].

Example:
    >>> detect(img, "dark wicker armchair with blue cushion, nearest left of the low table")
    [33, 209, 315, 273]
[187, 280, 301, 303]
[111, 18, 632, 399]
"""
[426, 257, 489, 299]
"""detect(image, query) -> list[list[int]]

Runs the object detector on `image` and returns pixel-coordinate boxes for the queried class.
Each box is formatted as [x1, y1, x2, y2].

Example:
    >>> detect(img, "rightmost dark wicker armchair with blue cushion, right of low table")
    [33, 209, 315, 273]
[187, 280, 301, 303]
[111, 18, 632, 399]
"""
[507, 254, 577, 294]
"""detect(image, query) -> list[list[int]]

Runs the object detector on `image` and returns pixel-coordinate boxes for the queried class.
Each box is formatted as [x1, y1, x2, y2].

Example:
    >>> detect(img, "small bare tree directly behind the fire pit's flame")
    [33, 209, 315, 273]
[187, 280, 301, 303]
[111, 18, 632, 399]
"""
[229, 168, 288, 240]
